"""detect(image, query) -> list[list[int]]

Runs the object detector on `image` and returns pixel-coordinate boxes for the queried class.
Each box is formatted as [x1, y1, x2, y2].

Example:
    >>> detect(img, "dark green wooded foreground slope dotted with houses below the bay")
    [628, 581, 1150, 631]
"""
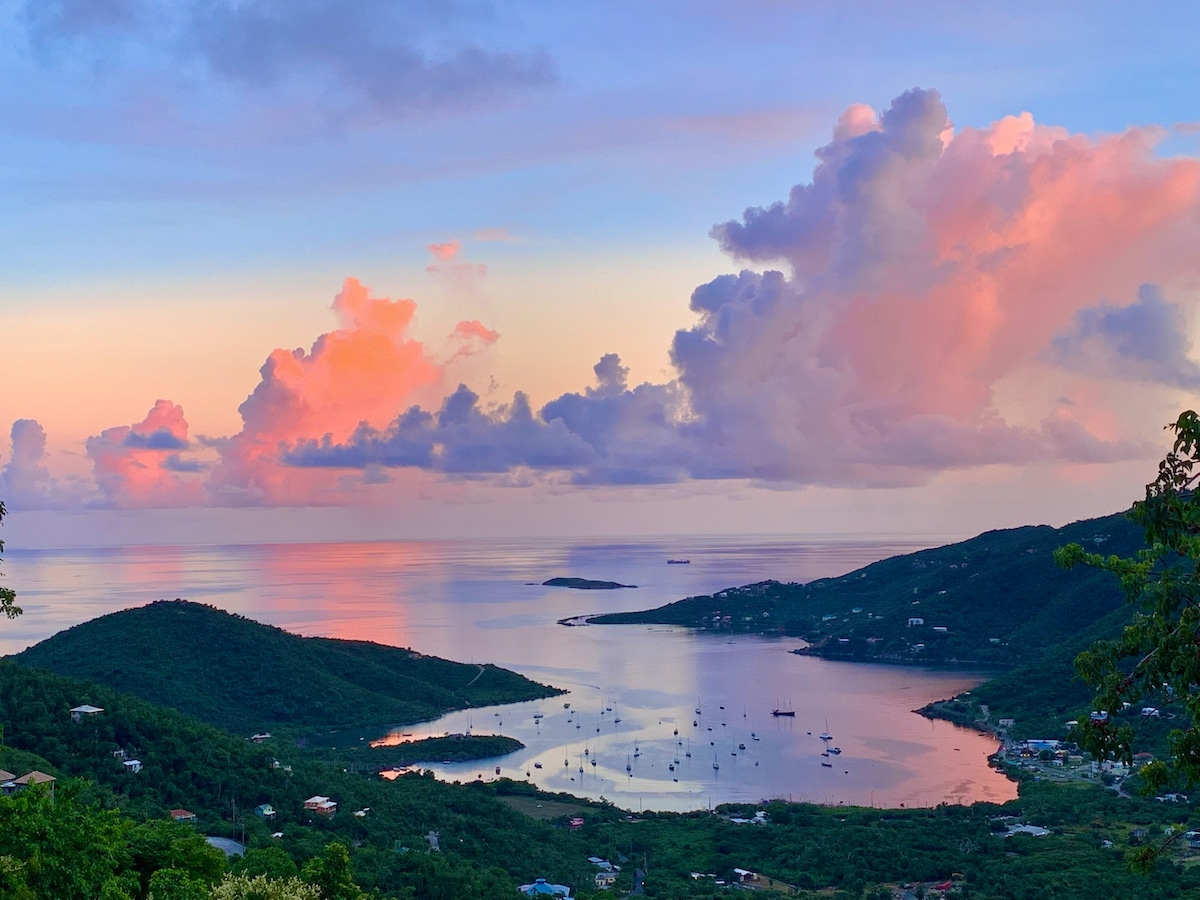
[0, 662, 1200, 900]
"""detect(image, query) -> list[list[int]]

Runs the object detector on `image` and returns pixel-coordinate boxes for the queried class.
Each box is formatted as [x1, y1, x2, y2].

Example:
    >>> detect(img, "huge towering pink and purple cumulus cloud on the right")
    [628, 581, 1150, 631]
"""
[289, 90, 1200, 485]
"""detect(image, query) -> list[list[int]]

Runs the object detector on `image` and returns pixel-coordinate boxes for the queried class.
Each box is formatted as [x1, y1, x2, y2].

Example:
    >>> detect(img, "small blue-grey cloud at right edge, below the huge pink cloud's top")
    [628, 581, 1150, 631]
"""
[1048, 284, 1200, 390]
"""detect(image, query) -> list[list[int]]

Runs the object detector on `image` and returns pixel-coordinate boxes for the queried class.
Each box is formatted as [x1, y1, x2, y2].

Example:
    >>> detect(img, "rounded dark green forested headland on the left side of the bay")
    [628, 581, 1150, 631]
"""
[13, 600, 558, 734]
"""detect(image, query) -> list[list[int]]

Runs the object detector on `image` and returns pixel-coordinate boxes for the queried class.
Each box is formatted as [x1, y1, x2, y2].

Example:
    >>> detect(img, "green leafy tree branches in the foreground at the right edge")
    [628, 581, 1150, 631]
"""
[1055, 410, 1200, 792]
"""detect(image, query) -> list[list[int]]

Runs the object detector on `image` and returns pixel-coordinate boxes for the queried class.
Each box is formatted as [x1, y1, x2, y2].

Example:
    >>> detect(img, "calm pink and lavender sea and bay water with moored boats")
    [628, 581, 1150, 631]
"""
[0, 536, 1015, 810]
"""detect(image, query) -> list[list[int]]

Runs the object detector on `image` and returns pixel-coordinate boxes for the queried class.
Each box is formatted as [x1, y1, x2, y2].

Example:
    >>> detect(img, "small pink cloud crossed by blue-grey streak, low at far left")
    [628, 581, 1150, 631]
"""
[88, 400, 204, 509]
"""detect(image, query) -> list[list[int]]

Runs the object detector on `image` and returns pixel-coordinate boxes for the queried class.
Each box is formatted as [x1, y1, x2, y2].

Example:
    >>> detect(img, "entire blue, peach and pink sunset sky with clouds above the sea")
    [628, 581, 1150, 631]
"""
[0, 0, 1200, 547]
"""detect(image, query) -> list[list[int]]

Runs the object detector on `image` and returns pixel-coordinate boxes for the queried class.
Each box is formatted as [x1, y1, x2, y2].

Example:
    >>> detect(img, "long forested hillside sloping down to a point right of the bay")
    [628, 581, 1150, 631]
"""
[588, 514, 1144, 666]
